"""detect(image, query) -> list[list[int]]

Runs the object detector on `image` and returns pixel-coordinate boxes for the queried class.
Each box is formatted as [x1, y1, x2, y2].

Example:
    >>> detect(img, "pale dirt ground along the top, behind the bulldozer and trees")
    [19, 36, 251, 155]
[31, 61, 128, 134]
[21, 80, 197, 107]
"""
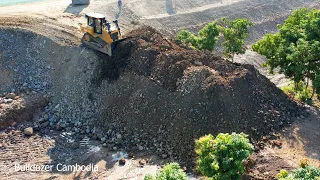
[0, 0, 318, 36]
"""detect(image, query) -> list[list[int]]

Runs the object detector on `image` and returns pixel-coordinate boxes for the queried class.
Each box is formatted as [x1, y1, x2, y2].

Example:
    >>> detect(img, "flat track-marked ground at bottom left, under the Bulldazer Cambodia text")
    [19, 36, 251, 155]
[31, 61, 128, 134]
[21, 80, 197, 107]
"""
[0, 120, 163, 180]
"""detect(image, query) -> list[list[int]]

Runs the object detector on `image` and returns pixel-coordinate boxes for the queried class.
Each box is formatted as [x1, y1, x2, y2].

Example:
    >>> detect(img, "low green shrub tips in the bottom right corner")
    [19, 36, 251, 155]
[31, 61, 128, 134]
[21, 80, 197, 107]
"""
[277, 165, 320, 180]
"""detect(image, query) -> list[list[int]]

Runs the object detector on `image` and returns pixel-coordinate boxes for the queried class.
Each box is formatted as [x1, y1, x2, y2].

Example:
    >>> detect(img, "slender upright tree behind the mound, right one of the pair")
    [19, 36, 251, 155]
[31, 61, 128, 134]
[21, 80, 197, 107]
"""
[219, 18, 253, 62]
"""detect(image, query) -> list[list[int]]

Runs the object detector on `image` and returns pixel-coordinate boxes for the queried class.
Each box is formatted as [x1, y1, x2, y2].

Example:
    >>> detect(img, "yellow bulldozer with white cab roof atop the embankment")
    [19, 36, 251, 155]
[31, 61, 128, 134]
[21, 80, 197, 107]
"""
[80, 12, 126, 56]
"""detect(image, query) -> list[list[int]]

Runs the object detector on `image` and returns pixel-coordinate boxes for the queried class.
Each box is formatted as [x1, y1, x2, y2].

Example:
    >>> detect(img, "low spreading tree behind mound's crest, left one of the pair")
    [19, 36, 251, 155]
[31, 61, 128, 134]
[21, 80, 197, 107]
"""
[177, 22, 219, 51]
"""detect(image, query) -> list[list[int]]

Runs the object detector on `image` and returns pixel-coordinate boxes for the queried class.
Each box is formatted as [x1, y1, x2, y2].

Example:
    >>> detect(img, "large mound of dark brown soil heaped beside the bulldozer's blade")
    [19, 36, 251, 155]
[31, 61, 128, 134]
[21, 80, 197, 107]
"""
[91, 27, 299, 165]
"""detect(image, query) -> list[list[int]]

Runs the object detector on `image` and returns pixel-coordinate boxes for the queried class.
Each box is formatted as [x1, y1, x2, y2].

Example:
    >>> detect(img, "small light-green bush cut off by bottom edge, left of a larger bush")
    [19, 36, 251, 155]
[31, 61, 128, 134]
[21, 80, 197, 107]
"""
[144, 163, 189, 180]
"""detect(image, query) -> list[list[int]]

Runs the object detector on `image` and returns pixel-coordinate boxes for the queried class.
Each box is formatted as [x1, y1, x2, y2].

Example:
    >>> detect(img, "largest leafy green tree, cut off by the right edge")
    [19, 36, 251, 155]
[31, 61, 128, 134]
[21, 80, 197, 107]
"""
[252, 8, 320, 99]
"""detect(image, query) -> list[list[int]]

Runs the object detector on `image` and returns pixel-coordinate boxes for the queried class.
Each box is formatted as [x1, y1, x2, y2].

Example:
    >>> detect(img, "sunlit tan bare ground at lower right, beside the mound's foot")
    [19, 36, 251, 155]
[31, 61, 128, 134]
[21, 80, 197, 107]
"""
[248, 107, 320, 179]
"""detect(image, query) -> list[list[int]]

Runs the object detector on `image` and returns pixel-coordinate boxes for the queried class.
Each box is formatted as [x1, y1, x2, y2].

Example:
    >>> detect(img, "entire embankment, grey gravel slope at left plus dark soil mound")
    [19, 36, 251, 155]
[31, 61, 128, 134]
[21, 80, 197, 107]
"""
[0, 27, 300, 165]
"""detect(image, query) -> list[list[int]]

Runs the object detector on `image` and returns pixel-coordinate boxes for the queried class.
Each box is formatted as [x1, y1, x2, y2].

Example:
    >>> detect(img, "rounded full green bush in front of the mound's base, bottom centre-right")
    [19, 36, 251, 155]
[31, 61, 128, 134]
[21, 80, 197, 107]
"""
[195, 133, 253, 180]
